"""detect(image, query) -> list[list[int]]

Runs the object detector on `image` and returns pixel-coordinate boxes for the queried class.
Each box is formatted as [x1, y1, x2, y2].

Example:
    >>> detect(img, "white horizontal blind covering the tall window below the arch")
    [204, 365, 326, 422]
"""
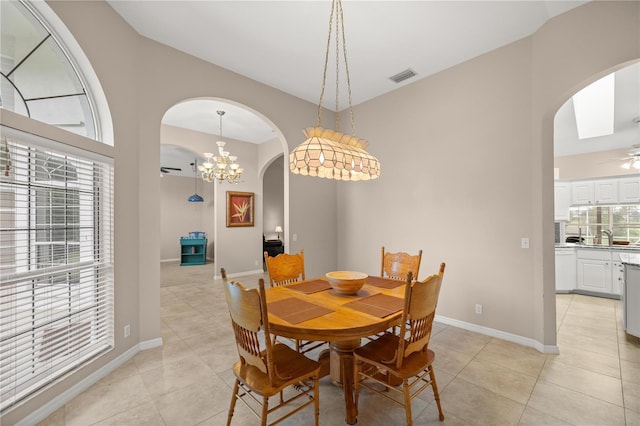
[0, 127, 114, 411]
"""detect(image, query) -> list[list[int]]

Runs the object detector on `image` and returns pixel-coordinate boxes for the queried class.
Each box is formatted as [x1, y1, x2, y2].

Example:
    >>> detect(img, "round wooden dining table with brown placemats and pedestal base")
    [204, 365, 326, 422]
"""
[266, 277, 405, 424]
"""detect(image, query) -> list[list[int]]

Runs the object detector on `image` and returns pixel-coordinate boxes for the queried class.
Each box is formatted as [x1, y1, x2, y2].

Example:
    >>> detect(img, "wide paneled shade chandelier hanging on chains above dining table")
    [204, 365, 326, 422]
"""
[289, 0, 380, 181]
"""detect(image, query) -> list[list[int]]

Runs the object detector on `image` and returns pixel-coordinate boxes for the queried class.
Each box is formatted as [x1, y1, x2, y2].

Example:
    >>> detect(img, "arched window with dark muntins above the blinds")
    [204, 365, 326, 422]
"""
[0, 1, 100, 139]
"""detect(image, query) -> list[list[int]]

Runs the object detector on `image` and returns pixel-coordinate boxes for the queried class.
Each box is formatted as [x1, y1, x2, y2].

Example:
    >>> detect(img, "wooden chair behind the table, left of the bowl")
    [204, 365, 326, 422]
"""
[264, 249, 327, 353]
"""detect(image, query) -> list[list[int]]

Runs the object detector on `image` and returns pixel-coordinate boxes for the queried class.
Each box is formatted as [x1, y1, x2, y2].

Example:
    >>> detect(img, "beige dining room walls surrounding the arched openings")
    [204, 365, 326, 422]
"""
[2, 1, 640, 423]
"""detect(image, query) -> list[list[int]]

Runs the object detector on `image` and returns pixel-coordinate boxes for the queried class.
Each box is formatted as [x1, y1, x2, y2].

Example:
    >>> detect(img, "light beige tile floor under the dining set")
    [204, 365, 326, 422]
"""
[41, 263, 640, 426]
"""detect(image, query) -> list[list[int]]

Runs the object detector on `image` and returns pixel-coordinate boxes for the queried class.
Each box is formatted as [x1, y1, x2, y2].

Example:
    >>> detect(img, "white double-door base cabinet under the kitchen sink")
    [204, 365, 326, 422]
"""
[576, 250, 612, 294]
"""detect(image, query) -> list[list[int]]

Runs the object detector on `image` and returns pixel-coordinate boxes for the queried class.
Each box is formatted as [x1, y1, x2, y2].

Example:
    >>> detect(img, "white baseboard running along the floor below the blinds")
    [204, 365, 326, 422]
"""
[16, 337, 162, 426]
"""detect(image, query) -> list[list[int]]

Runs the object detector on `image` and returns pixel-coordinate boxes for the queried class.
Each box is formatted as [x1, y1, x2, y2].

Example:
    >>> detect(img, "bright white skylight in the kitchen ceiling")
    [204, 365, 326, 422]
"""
[573, 74, 615, 139]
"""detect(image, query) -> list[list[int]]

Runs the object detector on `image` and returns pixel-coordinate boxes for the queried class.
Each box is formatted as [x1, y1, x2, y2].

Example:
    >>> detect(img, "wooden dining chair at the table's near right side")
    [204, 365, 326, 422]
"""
[354, 263, 445, 426]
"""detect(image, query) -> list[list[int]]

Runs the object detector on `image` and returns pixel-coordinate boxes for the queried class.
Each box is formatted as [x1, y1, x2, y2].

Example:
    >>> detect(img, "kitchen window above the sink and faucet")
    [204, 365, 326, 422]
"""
[566, 205, 640, 244]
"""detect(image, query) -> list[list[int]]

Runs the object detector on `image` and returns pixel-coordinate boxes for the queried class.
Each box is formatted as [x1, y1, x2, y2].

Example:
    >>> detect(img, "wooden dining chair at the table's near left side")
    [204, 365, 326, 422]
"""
[220, 268, 320, 426]
